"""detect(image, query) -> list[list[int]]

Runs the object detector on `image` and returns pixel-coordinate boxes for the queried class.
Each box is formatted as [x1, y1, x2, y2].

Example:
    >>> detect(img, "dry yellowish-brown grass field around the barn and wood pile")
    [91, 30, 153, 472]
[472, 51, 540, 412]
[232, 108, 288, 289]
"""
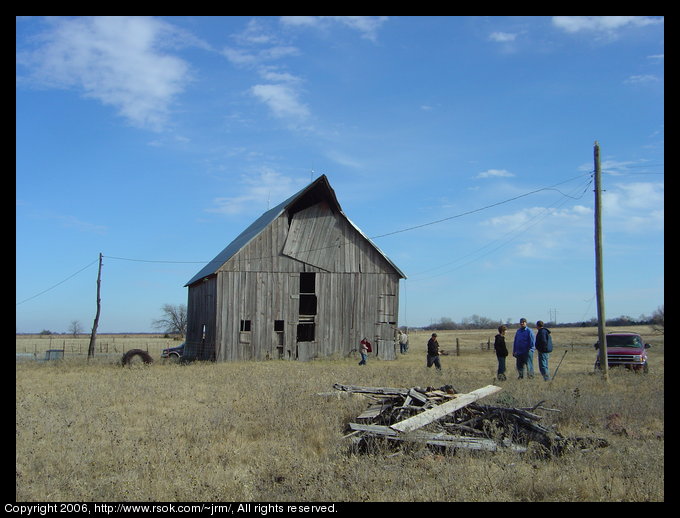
[16, 327, 664, 502]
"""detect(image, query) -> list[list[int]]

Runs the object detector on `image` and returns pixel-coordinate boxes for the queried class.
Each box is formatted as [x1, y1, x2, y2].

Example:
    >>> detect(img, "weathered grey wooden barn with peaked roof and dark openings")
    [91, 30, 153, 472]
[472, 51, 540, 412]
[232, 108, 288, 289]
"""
[185, 175, 405, 361]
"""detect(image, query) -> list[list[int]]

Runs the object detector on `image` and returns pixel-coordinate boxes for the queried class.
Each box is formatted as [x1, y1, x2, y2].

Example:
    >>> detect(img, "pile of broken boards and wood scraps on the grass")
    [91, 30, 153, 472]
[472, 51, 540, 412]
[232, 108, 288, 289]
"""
[333, 383, 608, 455]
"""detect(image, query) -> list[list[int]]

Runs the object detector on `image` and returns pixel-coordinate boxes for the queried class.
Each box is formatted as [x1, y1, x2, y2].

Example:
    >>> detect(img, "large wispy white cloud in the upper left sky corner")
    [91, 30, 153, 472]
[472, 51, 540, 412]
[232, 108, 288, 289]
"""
[17, 16, 197, 130]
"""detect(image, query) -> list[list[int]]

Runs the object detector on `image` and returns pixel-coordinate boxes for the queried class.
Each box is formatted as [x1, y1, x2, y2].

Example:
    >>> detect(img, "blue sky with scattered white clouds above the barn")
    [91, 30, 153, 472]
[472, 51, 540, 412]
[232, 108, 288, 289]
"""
[16, 16, 664, 332]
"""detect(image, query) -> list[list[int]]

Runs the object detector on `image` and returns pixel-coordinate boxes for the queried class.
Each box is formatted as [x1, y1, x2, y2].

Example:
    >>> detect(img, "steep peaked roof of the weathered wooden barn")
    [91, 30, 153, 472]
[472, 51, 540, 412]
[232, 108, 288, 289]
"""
[185, 175, 406, 286]
